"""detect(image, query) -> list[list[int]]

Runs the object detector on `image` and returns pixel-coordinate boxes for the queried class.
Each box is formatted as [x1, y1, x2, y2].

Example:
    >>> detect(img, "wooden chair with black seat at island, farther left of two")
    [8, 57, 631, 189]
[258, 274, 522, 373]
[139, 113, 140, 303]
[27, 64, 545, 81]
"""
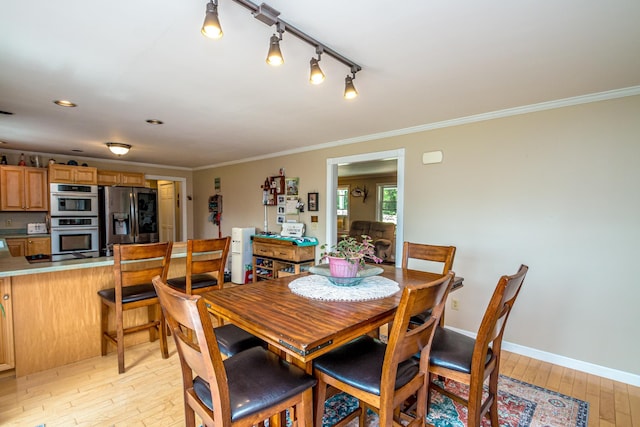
[98, 242, 173, 374]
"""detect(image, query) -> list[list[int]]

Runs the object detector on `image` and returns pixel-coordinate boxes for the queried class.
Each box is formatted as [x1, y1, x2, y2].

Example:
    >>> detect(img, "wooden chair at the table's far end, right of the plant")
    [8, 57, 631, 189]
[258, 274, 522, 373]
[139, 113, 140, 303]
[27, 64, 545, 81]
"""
[402, 242, 456, 325]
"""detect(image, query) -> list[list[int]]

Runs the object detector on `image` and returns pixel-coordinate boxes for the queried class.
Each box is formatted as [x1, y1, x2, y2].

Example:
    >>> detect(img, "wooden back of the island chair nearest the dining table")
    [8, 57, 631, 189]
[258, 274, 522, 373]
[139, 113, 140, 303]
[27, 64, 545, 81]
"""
[186, 236, 231, 294]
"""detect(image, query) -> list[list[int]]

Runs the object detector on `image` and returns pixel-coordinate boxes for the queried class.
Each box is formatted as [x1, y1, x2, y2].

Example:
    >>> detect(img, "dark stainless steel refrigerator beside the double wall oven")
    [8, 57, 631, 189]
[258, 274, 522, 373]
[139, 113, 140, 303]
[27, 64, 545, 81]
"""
[98, 187, 160, 256]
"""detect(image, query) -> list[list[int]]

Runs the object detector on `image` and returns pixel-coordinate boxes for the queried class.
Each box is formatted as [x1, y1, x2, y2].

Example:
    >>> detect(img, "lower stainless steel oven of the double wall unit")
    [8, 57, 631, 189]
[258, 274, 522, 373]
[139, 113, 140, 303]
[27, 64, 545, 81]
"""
[51, 217, 100, 261]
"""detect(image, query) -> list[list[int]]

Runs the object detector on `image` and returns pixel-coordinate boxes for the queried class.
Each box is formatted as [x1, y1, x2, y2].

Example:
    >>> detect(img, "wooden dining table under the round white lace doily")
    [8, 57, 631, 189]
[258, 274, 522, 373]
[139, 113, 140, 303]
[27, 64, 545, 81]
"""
[202, 266, 463, 373]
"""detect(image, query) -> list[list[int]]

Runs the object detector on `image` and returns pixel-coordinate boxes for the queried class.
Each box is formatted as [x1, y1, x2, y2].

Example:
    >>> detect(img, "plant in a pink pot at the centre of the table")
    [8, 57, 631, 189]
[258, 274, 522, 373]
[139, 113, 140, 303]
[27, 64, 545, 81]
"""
[320, 234, 382, 277]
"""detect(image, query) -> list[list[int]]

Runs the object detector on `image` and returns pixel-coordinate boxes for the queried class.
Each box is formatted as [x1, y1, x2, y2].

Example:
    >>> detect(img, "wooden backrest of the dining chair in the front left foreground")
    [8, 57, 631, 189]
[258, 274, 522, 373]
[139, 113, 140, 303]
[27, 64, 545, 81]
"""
[153, 277, 231, 426]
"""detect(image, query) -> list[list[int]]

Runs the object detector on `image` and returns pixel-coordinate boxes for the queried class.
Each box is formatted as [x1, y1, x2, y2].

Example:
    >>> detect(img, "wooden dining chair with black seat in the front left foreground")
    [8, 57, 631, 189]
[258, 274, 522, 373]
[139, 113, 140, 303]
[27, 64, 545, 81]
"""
[153, 277, 316, 427]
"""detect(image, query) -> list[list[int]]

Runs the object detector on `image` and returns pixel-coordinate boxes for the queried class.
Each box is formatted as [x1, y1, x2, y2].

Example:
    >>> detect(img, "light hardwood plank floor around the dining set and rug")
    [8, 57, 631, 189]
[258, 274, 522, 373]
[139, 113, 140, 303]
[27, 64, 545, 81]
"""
[0, 340, 640, 427]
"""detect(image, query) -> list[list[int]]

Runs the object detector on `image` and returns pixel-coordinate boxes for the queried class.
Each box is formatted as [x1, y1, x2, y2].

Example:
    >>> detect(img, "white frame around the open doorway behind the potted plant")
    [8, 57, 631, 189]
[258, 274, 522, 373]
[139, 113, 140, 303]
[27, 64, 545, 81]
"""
[325, 148, 405, 267]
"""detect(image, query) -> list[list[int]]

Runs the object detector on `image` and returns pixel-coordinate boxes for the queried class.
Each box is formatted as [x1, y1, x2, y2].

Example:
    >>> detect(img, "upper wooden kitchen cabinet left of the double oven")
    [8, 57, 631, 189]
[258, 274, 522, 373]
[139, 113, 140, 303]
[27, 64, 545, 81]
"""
[0, 166, 49, 212]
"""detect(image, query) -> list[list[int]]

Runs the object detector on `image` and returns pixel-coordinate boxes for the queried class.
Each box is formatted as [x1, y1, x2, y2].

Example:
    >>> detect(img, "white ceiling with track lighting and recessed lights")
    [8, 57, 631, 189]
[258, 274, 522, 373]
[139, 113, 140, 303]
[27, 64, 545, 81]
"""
[0, 0, 640, 168]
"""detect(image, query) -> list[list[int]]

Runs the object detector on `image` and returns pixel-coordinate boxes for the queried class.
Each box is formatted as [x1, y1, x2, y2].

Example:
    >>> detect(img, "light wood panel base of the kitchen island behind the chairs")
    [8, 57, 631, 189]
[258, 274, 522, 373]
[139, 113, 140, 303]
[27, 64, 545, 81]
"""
[11, 258, 186, 377]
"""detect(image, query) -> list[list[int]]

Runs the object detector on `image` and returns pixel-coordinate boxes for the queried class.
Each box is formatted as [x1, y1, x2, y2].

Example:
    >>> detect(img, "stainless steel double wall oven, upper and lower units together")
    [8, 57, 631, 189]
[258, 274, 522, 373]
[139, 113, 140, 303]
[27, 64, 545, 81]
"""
[49, 184, 100, 261]
